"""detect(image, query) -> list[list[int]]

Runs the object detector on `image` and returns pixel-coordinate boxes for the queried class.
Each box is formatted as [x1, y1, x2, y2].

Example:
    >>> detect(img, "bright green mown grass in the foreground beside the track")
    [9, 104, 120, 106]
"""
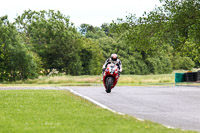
[0, 90, 197, 133]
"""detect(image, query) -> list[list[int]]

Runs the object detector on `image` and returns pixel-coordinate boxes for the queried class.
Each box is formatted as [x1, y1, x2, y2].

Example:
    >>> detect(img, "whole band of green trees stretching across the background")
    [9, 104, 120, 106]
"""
[0, 0, 200, 82]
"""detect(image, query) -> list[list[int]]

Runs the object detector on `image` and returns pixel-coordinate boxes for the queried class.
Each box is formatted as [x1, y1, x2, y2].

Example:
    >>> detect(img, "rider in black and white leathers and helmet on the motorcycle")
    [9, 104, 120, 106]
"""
[102, 54, 122, 76]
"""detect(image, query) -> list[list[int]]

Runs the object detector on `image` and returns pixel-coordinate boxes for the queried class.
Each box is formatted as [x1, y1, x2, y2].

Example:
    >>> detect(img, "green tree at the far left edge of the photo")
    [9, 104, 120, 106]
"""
[0, 16, 40, 81]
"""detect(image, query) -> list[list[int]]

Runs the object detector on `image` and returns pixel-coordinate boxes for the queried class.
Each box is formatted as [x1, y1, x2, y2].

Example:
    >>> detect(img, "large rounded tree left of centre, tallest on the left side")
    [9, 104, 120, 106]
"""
[16, 10, 82, 75]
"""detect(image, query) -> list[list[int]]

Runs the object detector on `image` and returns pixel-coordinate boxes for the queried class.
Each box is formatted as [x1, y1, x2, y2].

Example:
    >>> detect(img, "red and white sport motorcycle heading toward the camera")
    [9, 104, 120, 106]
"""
[103, 63, 119, 93]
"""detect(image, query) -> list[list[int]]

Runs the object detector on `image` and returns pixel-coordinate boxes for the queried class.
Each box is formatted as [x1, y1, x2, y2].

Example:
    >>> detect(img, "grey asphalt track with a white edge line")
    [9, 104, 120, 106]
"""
[0, 86, 200, 131]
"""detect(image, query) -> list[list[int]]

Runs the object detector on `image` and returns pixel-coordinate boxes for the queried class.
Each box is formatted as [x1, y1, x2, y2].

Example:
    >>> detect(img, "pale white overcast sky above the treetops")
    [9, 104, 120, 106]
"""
[0, 0, 161, 26]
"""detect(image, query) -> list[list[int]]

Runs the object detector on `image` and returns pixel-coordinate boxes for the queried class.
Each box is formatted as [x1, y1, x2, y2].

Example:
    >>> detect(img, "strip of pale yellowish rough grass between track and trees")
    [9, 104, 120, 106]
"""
[0, 70, 200, 86]
